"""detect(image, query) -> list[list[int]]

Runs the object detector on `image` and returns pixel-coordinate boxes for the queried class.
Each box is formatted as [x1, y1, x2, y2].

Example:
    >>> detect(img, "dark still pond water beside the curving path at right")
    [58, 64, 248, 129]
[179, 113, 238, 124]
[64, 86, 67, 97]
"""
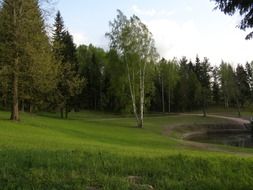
[188, 133, 253, 148]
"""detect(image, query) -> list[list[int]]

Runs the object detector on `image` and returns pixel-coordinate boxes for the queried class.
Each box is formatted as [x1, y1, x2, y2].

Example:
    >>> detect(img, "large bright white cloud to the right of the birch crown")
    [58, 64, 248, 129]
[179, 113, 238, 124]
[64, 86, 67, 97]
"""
[131, 3, 253, 64]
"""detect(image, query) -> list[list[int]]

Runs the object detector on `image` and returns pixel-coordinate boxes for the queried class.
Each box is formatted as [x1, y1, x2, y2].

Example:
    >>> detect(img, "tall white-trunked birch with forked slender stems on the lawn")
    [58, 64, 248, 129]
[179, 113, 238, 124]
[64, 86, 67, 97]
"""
[106, 10, 158, 128]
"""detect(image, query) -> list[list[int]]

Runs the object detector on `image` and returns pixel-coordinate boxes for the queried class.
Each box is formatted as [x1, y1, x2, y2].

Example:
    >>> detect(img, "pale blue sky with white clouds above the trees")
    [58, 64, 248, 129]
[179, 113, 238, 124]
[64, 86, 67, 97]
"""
[52, 0, 253, 65]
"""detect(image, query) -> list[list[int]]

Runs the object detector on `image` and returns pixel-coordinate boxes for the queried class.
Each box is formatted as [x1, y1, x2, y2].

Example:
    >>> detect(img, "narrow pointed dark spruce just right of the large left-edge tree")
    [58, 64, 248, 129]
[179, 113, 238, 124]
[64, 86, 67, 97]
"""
[53, 11, 84, 118]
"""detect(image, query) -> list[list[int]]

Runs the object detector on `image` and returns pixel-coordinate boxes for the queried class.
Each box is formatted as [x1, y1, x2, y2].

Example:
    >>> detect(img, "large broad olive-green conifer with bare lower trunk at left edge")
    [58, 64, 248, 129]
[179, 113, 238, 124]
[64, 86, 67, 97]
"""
[0, 0, 57, 120]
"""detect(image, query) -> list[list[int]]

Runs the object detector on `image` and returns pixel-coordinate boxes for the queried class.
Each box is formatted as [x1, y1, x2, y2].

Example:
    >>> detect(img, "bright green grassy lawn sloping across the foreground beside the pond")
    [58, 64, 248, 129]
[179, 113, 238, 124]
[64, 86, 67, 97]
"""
[0, 112, 253, 190]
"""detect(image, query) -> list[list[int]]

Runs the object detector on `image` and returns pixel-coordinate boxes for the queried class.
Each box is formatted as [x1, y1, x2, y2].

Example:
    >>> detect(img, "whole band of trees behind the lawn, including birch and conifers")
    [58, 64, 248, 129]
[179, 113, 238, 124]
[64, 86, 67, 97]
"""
[0, 0, 253, 128]
